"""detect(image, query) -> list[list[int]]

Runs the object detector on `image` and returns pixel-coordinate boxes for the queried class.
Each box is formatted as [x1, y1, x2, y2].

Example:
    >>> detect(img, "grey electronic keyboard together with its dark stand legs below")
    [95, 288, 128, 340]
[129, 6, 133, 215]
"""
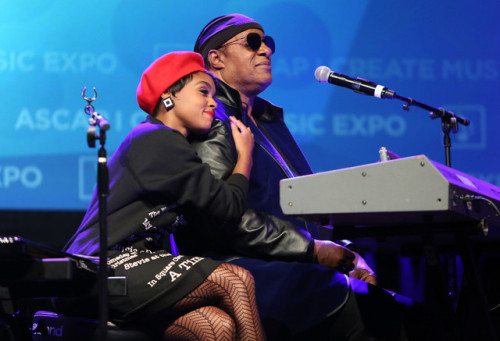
[280, 155, 500, 340]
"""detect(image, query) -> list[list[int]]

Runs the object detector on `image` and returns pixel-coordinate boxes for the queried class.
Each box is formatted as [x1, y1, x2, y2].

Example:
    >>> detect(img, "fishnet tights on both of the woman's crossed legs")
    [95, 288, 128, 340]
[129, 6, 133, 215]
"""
[164, 263, 265, 341]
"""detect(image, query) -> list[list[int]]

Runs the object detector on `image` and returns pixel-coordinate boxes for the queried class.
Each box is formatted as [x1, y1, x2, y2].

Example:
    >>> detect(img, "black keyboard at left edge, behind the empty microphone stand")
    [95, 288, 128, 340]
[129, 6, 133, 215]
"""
[0, 236, 127, 301]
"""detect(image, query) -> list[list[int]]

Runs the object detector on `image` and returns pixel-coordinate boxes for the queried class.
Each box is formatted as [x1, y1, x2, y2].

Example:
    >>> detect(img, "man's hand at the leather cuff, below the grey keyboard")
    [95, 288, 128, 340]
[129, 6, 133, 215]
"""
[314, 240, 377, 285]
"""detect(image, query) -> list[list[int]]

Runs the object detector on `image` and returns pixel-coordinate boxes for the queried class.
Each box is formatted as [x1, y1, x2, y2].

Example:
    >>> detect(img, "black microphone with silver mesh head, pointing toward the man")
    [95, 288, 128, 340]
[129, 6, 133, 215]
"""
[314, 66, 396, 99]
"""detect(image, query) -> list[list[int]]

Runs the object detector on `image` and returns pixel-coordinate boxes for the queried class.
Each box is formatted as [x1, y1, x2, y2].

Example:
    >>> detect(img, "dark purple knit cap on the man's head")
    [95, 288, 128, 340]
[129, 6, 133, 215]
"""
[194, 14, 264, 60]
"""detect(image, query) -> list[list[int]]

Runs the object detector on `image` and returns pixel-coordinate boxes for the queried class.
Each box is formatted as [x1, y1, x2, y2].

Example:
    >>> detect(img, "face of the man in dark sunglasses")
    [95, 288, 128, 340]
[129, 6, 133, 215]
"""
[219, 29, 273, 96]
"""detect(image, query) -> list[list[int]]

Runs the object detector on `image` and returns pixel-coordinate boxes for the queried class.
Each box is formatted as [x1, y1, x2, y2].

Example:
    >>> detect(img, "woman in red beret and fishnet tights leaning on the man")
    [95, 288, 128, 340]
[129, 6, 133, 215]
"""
[65, 52, 264, 340]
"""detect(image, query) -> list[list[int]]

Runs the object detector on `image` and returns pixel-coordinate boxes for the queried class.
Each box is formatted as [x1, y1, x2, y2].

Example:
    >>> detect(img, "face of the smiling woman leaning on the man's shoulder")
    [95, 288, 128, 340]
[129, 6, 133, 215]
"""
[162, 72, 217, 136]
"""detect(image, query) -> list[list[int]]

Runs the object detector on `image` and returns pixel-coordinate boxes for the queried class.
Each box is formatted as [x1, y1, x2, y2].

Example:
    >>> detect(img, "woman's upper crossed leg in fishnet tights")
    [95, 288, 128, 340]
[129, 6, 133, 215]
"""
[167, 263, 265, 341]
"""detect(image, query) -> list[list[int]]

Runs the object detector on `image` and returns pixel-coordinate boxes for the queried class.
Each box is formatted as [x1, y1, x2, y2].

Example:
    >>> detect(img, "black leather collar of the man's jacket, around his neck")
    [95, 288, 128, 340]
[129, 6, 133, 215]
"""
[215, 80, 283, 122]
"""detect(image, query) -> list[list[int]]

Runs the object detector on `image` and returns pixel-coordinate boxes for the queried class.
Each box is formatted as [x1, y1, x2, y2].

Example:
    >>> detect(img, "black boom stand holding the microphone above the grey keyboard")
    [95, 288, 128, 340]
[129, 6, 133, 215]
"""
[391, 93, 470, 167]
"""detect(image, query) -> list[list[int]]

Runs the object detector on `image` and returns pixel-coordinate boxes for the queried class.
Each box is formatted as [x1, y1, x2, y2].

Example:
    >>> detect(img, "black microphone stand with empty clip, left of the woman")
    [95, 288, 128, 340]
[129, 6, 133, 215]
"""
[82, 87, 110, 341]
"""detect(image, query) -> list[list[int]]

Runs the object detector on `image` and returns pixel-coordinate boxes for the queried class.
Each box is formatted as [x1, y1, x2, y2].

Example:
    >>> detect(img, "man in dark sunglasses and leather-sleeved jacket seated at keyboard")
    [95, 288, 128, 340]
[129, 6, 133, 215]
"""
[175, 14, 438, 340]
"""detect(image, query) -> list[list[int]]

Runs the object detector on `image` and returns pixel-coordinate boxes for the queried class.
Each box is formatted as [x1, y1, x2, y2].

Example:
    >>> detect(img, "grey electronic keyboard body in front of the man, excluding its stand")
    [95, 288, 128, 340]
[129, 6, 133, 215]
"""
[280, 155, 500, 235]
